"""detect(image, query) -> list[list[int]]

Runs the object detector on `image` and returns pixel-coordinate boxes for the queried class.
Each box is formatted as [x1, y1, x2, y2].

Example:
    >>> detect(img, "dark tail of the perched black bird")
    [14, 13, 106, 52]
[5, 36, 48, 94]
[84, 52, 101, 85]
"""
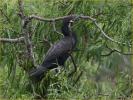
[29, 66, 48, 82]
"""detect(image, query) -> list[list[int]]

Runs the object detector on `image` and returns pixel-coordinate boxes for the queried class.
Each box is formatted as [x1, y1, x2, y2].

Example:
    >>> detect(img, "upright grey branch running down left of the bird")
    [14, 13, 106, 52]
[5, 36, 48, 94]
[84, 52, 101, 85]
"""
[18, 0, 37, 67]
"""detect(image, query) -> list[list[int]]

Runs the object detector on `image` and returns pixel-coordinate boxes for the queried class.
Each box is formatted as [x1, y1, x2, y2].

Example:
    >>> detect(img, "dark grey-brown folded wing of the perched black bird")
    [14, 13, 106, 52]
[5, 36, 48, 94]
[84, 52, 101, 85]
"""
[44, 37, 72, 61]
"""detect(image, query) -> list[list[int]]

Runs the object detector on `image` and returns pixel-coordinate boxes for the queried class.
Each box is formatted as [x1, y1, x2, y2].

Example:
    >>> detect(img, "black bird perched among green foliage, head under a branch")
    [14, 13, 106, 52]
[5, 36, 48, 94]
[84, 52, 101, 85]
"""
[29, 16, 77, 81]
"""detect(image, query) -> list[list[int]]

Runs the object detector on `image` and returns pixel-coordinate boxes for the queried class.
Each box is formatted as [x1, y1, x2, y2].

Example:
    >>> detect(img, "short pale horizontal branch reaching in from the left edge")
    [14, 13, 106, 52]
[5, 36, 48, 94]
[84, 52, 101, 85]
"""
[0, 37, 24, 43]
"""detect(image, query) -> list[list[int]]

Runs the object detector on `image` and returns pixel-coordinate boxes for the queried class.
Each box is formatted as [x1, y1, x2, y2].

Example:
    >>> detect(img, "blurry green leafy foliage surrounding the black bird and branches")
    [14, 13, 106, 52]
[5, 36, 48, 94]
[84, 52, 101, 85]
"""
[0, 0, 132, 100]
